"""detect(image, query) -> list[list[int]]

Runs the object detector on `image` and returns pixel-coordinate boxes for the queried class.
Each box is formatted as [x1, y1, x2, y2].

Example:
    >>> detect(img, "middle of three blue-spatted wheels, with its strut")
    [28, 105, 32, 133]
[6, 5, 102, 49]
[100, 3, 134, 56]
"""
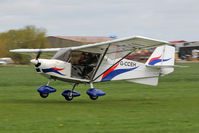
[62, 83, 80, 101]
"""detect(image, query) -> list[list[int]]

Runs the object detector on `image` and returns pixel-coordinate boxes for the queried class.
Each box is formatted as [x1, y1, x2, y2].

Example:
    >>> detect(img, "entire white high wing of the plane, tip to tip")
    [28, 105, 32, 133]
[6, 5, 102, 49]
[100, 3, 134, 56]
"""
[10, 36, 169, 57]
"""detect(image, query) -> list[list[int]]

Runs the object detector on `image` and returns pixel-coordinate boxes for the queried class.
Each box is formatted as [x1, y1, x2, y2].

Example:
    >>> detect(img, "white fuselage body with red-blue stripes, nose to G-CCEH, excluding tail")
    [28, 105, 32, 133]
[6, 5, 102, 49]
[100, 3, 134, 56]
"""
[31, 59, 159, 82]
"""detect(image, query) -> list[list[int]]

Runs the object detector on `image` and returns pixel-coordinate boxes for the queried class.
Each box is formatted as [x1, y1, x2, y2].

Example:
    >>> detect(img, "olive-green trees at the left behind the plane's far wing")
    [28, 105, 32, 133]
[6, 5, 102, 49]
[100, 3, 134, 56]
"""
[0, 25, 49, 64]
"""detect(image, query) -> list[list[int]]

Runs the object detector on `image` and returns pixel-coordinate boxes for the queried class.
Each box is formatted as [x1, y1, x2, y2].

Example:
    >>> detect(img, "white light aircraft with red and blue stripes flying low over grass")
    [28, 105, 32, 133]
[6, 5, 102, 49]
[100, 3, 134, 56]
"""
[10, 36, 175, 101]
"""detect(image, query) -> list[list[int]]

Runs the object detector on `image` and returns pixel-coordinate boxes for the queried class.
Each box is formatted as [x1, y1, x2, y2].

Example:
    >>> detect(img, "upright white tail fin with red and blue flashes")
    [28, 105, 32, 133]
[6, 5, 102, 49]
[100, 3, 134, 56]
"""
[145, 45, 175, 75]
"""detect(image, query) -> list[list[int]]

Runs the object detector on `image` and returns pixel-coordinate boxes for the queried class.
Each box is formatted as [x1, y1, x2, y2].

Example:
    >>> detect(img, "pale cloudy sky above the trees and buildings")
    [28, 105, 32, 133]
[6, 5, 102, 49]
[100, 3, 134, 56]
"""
[0, 0, 199, 41]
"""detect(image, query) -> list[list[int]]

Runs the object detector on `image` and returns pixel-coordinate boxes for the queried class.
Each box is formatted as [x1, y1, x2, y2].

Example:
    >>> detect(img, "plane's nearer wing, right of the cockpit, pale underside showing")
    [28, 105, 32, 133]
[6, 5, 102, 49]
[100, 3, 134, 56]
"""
[72, 36, 169, 54]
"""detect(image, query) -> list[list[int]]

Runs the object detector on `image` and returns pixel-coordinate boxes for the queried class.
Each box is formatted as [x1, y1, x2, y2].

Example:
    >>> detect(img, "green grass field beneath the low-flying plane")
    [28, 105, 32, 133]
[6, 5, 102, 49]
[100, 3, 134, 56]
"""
[0, 63, 199, 133]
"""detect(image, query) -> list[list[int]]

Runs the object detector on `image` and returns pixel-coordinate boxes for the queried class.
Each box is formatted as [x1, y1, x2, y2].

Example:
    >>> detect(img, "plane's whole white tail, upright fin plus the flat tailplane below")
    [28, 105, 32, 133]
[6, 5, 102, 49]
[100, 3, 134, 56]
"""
[127, 45, 175, 86]
